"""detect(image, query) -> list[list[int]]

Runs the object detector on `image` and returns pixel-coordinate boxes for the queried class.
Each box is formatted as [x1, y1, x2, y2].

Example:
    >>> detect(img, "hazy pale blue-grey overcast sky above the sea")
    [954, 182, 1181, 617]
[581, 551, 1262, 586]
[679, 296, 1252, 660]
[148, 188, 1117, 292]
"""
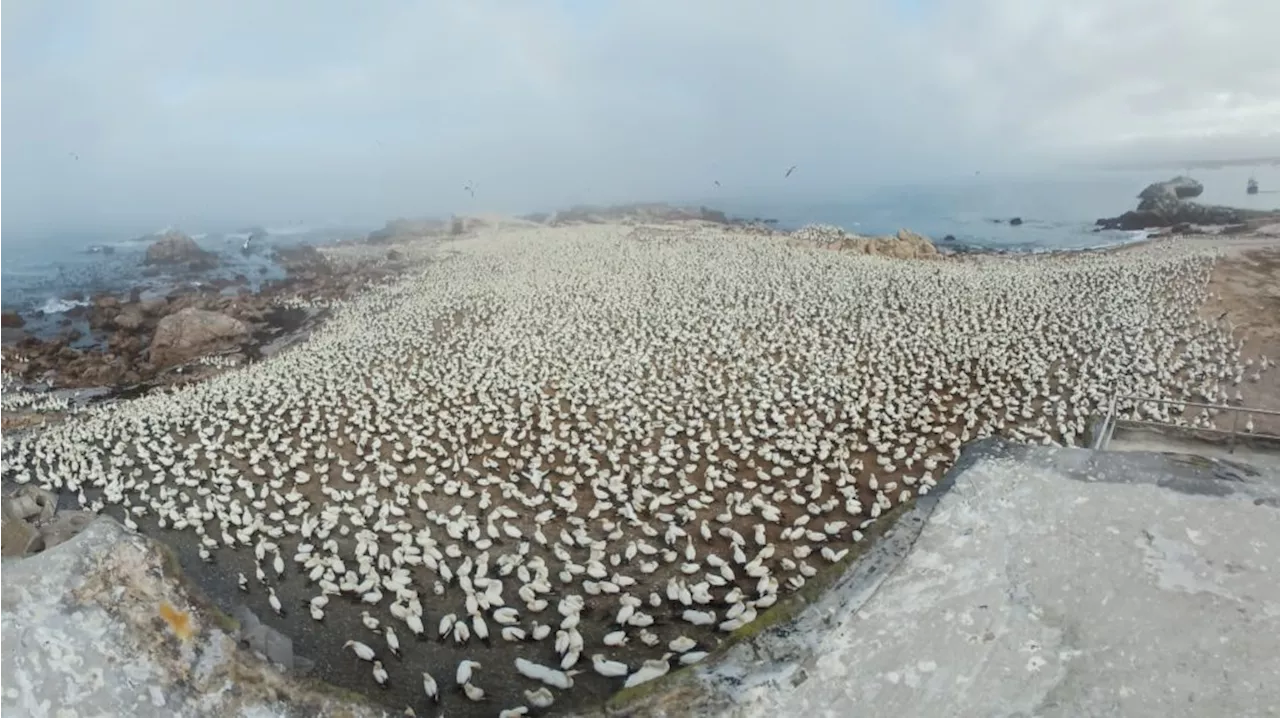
[0, 0, 1280, 232]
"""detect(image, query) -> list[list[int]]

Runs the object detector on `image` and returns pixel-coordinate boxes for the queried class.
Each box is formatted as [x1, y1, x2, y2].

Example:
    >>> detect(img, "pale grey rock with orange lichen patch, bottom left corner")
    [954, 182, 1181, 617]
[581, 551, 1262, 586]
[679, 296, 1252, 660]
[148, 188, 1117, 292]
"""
[0, 518, 384, 718]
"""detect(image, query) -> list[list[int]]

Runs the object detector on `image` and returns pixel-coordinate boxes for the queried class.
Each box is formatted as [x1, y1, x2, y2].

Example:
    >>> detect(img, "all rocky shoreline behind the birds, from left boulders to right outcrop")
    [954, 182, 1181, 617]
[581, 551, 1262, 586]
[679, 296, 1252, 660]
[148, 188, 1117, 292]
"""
[0, 188, 1280, 419]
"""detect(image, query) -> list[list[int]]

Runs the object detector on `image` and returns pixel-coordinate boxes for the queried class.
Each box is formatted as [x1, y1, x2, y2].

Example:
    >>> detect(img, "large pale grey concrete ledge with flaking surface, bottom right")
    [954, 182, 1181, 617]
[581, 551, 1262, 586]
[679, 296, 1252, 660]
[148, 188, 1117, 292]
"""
[586, 440, 1280, 718]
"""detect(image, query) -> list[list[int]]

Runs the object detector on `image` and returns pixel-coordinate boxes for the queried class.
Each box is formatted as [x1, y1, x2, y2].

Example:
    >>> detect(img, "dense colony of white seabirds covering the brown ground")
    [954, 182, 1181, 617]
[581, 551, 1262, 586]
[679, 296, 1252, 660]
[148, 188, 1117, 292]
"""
[0, 225, 1267, 718]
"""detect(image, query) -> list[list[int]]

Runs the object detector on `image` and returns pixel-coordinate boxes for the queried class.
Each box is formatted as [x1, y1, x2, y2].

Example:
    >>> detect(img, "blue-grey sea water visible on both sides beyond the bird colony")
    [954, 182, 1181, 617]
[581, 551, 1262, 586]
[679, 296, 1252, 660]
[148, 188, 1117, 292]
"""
[0, 166, 1280, 321]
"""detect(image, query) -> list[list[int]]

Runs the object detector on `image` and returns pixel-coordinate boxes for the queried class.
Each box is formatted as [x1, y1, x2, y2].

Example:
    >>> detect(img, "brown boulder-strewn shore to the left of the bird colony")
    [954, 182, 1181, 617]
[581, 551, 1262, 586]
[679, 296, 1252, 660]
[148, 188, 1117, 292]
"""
[0, 233, 417, 415]
